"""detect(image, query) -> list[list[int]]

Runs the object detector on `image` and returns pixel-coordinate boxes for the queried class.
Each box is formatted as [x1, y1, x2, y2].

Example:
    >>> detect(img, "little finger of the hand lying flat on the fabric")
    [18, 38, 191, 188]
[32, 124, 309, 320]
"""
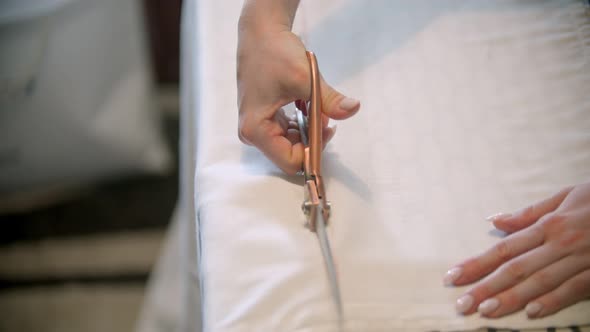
[525, 269, 590, 318]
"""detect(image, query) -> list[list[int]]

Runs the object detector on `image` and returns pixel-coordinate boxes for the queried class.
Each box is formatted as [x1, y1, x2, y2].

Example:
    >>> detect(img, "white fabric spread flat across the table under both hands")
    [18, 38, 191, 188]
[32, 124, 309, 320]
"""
[194, 0, 590, 331]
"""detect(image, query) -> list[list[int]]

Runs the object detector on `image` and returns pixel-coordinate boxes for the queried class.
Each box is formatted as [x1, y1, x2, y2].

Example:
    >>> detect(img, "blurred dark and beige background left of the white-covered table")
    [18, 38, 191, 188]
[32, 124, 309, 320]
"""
[0, 0, 182, 331]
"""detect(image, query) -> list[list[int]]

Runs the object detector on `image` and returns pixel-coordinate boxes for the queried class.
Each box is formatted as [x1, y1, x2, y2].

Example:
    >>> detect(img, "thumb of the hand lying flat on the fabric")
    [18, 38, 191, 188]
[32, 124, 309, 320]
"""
[488, 187, 573, 233]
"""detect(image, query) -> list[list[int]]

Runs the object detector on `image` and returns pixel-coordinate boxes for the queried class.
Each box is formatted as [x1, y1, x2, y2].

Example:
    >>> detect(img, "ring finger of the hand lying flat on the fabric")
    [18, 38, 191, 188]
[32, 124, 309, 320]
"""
[478, 256, 588, 318]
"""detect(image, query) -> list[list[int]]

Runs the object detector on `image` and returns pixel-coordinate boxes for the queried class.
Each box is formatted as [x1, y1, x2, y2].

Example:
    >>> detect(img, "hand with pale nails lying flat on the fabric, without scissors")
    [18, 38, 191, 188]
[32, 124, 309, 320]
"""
[445, 183, 590, 318]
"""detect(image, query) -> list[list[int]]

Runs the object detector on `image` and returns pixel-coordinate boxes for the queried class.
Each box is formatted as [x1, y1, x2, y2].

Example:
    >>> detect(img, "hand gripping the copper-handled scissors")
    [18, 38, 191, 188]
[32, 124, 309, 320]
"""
[237, 20, 360, 174]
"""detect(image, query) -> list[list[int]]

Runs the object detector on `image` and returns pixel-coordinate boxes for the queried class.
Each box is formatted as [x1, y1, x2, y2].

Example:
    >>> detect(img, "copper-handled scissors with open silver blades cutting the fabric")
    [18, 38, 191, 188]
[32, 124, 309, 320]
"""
[296, 51, 342, 323]
